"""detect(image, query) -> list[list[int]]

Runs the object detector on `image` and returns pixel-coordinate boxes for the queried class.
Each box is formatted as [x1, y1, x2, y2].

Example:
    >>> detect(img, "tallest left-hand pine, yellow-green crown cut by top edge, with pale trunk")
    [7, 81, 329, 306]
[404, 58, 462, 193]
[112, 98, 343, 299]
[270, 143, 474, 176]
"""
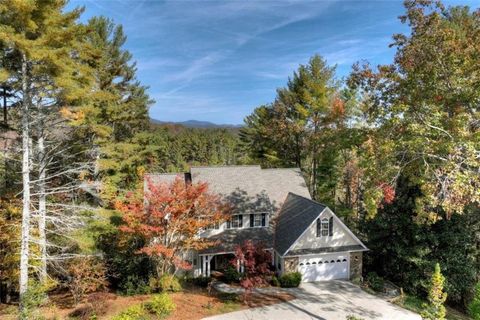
[0, 0, 91, 308]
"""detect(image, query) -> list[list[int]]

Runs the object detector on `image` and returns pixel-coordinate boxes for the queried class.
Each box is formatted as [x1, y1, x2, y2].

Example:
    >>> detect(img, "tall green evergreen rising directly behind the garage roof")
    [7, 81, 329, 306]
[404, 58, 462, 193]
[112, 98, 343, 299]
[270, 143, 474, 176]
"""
[240, 55, 356, 202]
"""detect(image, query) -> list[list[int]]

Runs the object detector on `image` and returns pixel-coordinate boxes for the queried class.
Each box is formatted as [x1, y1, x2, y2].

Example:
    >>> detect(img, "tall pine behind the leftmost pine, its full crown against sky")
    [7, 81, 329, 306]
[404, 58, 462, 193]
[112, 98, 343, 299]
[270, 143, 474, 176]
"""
[79, 17, 153, 202]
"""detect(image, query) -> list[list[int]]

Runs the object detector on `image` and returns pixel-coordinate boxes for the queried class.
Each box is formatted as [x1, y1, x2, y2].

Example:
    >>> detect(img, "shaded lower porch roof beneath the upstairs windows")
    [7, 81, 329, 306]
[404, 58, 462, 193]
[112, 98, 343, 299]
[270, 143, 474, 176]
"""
[199, 228, 273, 253]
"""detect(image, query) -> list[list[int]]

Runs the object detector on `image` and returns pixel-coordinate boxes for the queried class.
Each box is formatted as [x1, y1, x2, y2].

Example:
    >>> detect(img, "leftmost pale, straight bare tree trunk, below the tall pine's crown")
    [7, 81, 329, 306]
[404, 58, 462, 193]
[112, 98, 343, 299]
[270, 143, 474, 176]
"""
[19, 54, 30, 308]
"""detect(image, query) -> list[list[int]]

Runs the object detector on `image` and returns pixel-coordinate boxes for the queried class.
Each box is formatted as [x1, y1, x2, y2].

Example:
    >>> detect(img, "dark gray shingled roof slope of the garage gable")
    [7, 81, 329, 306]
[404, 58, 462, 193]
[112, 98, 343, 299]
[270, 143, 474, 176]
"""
[274, 193, 326, 256]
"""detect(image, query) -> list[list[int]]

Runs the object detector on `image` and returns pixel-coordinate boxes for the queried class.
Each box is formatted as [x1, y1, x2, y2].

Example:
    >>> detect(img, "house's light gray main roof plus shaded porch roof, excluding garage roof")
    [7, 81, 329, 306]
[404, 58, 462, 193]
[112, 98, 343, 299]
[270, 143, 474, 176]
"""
[147, 166, 310, 253]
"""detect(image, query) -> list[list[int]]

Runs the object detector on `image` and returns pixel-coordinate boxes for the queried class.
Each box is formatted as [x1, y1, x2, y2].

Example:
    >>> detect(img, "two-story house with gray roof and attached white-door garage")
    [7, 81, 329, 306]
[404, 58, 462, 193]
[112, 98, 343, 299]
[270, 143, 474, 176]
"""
[148, 166, 368, 282]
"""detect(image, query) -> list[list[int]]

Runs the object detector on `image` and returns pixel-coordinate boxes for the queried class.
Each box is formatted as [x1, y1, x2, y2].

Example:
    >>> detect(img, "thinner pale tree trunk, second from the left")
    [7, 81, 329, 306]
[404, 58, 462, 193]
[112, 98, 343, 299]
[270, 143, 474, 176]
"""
[37, 116, 47, 283]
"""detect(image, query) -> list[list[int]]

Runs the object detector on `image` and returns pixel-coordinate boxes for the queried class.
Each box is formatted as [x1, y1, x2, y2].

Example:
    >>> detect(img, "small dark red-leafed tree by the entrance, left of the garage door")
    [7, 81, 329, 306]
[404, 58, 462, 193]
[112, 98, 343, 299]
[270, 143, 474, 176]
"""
[231, 240, 273, 300]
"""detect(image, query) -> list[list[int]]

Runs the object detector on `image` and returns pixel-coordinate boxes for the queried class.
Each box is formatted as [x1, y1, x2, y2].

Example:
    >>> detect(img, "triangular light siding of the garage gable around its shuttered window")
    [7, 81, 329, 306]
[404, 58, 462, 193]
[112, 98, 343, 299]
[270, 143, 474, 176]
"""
[291, 208, 358, 250]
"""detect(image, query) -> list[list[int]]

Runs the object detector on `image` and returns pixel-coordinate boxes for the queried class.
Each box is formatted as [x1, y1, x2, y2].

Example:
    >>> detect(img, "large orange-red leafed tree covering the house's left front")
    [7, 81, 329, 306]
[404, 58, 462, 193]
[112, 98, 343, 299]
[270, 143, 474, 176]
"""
[116, 178, 228, 276]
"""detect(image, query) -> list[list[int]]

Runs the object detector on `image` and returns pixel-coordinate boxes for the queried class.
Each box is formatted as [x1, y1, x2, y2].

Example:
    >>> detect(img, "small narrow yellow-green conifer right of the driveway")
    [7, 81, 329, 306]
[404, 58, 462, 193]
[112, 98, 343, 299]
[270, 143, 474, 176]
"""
[422, 263, 447, 320]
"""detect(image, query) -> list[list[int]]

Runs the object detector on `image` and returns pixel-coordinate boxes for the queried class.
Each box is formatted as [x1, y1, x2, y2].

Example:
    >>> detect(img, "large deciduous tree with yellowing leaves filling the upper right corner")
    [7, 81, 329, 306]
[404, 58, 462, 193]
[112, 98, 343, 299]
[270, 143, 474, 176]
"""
[349, 0, 480, 222]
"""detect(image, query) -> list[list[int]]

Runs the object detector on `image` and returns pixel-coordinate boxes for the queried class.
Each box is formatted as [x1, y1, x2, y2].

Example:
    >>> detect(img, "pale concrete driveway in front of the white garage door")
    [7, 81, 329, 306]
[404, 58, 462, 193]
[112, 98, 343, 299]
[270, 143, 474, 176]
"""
[207, 280, 421, 320]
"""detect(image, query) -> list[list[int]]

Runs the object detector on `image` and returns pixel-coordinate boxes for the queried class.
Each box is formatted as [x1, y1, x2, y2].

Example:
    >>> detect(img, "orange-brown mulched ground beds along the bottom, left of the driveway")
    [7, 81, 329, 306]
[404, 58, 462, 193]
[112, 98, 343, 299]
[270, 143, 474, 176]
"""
[0, 287, 294, 320]
